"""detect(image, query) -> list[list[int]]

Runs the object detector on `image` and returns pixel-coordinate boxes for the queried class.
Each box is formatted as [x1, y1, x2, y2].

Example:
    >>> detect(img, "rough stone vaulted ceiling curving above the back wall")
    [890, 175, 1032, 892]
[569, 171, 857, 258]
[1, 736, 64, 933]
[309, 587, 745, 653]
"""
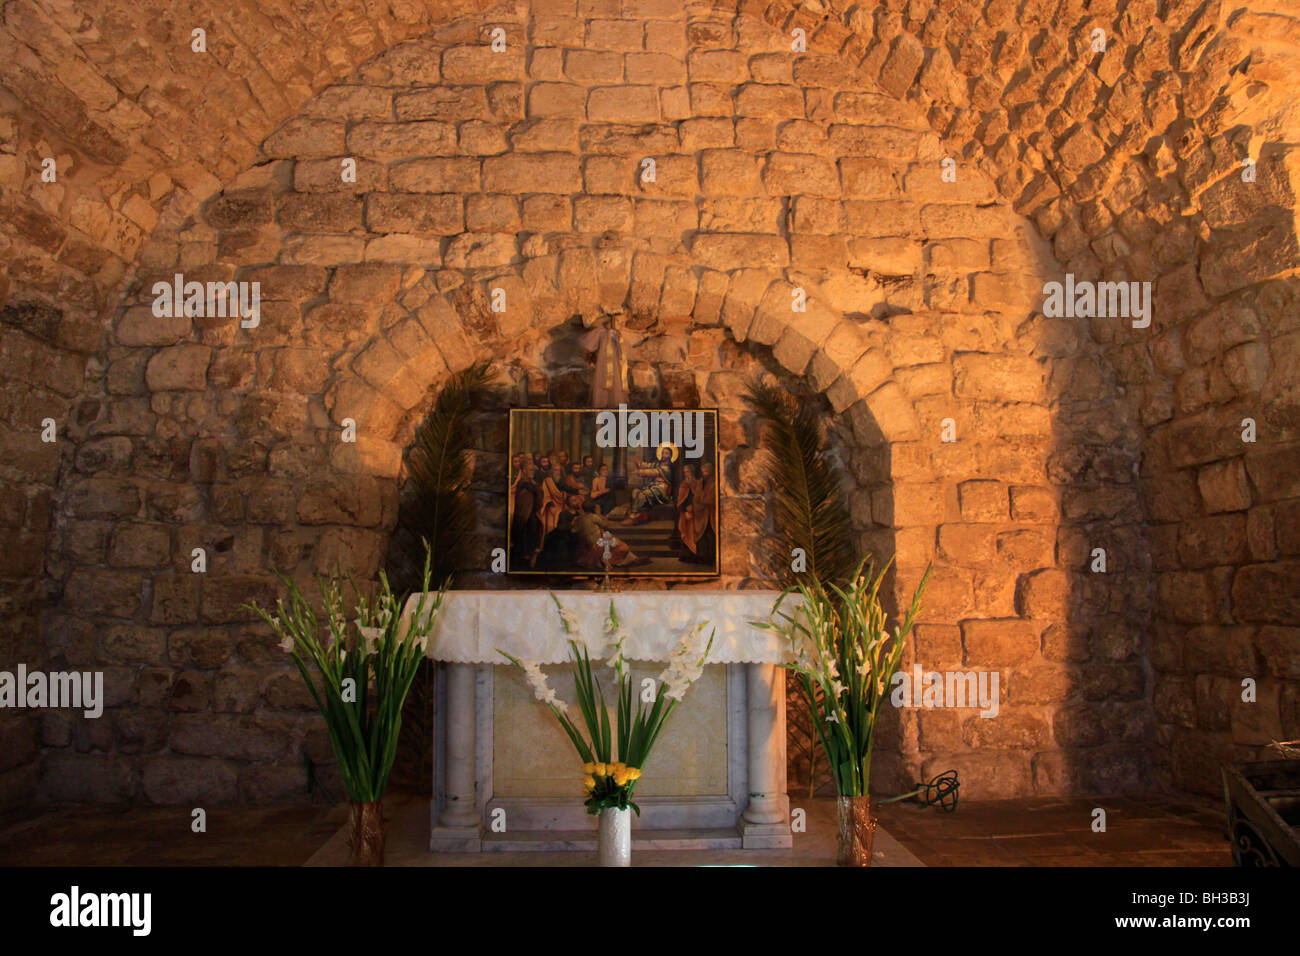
[0, 0, 1300, 325]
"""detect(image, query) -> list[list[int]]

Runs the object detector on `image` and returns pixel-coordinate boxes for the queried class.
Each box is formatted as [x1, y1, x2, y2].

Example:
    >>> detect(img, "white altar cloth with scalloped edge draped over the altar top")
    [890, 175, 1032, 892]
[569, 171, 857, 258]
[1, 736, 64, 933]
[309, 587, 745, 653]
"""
[403, 589, 797, 663]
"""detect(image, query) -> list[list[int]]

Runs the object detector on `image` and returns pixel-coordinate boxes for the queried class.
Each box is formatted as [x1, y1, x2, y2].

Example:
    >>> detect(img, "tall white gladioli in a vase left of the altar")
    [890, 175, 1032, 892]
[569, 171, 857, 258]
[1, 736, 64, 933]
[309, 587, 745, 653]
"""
[246, 553, 446, 862]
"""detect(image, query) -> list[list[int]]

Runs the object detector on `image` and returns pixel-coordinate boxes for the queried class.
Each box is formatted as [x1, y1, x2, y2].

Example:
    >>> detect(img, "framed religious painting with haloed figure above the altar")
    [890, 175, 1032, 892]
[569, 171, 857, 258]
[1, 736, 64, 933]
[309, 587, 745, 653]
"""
[507, 406, 720, 578]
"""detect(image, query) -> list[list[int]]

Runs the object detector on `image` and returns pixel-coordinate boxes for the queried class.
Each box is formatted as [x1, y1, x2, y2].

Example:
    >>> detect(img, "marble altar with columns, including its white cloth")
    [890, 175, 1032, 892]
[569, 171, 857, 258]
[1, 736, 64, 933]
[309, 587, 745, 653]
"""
[407, 589, 790, 852]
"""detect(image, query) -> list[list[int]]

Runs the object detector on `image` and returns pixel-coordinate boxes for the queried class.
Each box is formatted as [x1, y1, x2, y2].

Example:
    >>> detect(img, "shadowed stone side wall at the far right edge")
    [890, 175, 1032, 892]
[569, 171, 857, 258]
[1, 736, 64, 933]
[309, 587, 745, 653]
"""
[1143, 274, 1300, 793]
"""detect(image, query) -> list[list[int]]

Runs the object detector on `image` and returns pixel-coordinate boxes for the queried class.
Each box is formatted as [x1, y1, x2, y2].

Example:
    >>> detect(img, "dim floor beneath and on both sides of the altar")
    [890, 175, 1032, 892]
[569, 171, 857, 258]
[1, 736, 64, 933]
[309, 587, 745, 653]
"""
[0, 797, 1231, 866]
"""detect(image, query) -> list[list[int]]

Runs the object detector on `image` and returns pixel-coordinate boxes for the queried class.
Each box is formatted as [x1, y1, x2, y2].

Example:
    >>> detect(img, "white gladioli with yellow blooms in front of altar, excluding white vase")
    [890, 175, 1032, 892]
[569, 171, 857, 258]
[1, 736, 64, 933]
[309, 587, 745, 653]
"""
[498, 594, 714, 816]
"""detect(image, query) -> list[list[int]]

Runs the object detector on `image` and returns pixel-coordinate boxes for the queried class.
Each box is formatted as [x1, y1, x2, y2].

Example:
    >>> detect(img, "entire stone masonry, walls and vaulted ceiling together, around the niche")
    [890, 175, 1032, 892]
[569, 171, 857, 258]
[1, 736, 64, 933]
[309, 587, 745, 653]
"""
[0, 0, 1300, 801]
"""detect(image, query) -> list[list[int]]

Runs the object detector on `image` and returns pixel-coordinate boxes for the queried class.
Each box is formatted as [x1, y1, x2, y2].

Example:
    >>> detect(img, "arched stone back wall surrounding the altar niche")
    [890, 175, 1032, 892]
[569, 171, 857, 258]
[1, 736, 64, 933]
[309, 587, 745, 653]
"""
[35, 3, 1144, 800]
